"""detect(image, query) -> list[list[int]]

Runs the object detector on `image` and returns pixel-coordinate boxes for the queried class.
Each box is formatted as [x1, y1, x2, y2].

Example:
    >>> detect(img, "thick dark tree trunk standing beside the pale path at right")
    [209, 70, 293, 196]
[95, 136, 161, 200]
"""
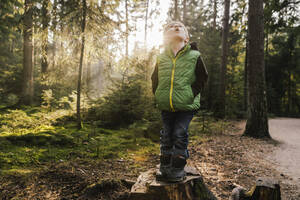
[244, 0, 270, 138]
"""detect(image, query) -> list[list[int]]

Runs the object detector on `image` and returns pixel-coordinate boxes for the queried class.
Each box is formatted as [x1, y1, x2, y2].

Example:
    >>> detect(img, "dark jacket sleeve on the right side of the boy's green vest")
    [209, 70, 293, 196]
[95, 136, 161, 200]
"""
[192, 56, 208, 97]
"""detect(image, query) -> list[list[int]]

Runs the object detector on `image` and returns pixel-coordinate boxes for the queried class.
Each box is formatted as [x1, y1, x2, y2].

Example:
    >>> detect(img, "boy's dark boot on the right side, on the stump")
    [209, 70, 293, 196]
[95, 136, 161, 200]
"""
[168, 155, 186, 182]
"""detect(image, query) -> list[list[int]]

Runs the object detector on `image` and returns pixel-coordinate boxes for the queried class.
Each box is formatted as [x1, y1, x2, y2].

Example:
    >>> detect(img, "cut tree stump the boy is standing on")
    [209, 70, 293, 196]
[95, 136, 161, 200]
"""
[129, 166, 216, 200]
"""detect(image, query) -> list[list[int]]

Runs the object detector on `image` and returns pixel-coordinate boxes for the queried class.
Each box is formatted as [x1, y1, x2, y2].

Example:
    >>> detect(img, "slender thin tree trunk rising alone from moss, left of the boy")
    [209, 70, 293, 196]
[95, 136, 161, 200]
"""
[77, 0, 87, 129]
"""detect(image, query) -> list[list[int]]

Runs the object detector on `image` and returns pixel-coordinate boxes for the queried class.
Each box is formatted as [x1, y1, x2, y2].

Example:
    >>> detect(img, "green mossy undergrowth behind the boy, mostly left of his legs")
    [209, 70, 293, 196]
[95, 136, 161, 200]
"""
[0, 107, 228, 177]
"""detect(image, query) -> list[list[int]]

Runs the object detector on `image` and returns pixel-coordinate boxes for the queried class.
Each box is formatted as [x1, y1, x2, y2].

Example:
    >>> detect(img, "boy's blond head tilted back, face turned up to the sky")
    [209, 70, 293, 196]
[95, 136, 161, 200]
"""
[163, 21, 190, 44]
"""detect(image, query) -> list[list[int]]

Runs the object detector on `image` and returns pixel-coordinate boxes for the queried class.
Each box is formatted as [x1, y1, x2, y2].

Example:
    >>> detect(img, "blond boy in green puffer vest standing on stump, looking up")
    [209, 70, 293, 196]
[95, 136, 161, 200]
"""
[151, 21, 208, 182]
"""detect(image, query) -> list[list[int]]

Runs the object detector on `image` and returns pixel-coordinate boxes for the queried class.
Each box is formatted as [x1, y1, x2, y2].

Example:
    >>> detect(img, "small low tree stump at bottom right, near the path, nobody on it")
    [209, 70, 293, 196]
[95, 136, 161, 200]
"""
[230, 178, 281, 200]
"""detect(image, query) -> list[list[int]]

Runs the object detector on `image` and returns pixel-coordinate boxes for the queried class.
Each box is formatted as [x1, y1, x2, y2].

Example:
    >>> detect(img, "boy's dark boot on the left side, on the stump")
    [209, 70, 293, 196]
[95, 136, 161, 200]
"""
[156, 154, 172, 181]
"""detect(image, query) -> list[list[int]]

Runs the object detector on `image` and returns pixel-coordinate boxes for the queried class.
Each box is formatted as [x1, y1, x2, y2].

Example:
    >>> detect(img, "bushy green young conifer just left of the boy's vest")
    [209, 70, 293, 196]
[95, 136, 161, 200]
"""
[88, 50, 160, 127]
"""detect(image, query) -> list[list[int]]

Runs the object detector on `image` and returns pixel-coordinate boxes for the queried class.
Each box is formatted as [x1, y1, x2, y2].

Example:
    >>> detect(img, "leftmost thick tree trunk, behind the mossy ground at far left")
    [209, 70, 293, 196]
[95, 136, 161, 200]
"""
[22, 0, 34, 105]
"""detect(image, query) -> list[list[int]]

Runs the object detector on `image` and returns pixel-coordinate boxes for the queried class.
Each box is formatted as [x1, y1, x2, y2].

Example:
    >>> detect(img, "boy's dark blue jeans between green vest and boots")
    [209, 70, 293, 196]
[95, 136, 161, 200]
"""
[160, 111, 197, 159]
